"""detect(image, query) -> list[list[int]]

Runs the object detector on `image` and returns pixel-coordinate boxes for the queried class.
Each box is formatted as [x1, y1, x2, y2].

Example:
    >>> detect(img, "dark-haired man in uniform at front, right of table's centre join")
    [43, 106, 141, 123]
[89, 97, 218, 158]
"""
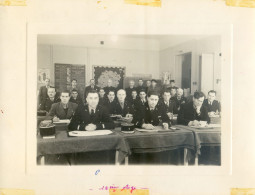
[132, 91, 171, 130]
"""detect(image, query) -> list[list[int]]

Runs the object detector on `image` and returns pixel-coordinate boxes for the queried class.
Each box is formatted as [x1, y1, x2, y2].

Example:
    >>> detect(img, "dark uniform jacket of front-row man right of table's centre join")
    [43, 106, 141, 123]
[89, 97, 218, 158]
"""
[132, 102, 171, 128]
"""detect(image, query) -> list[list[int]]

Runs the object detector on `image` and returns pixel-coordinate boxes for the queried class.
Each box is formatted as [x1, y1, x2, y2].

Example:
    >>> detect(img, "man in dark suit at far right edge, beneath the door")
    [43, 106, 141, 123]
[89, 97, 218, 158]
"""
[204, 90, 221, 115]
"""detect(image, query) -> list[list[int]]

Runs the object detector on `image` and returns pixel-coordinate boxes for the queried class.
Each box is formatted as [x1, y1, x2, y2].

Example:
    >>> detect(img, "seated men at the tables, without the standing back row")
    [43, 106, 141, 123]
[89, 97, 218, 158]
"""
[41, 85, 220, 130]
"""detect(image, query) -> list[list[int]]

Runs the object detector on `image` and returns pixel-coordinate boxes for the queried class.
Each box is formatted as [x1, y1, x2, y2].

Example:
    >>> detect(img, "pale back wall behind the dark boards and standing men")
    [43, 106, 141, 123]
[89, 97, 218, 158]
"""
[37, 45, 160, 87]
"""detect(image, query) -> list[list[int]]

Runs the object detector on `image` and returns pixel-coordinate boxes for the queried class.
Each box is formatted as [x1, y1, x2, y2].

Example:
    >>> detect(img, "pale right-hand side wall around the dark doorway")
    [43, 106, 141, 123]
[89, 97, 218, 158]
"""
[160, 36, 221, 98]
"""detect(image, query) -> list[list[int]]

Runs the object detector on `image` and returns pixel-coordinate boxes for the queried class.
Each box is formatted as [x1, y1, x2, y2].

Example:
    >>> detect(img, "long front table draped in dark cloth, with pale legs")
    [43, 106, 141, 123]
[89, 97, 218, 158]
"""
[37, 125, 221, 165]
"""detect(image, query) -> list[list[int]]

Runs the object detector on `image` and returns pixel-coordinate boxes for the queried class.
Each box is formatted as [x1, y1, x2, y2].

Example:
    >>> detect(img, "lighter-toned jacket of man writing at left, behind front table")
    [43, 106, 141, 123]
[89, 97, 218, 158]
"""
[45, 102, 78, 120]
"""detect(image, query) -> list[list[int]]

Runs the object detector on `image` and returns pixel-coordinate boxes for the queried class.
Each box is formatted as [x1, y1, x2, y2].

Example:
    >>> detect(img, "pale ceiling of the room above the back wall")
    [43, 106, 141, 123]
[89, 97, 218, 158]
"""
[38, 34, 209, 51]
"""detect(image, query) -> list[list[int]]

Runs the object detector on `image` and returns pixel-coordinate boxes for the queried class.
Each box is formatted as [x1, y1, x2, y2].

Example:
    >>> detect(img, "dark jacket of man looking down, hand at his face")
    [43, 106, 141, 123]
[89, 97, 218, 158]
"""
[177, 101, 210, 125]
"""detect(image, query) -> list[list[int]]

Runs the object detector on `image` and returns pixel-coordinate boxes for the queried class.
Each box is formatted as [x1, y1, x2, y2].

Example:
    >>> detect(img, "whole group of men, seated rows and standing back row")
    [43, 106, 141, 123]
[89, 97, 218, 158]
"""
[39, 79, 221, 131]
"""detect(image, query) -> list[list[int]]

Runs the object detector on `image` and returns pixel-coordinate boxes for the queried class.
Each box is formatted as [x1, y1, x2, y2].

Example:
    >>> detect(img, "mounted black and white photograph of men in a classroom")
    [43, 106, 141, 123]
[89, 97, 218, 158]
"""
[34, 34, 222, 166]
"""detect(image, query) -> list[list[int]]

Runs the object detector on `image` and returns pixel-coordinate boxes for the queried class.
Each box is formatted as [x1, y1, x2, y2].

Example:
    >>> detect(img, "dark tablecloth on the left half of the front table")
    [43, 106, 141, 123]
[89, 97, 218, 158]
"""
[37, 131, 130, 162]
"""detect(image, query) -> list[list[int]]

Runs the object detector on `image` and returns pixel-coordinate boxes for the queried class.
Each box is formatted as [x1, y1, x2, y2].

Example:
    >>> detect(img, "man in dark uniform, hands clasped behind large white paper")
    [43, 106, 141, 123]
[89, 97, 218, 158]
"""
[68, 90, 114, 131]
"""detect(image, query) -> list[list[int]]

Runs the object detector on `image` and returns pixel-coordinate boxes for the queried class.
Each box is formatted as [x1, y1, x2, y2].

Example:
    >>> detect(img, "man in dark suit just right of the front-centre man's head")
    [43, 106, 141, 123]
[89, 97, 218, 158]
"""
[159, 90, 178, 119]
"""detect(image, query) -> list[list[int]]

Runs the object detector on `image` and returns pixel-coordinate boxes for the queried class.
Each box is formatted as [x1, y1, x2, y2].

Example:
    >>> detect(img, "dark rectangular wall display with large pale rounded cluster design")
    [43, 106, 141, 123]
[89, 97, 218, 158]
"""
[93, 65, 126, 88]
